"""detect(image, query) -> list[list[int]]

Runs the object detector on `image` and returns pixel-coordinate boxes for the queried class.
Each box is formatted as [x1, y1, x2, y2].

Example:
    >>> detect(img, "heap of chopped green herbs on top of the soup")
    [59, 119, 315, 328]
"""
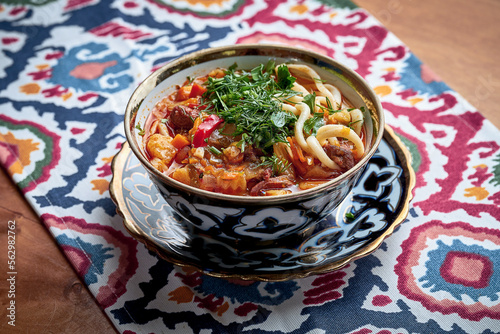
[203, 62, 298, 153]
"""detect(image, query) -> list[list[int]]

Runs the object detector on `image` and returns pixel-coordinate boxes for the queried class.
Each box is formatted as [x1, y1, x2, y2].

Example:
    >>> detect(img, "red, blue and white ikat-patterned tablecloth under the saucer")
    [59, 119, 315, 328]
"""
[0, 0, 500, 334]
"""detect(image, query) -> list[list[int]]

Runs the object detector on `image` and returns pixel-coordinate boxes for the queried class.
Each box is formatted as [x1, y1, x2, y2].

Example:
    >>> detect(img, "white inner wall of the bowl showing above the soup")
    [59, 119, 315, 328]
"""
[125, 45, 384, 201]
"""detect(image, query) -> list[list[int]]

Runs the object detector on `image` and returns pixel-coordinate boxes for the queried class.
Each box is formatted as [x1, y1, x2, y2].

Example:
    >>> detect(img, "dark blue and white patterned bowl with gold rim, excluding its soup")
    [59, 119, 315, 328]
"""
[125, 44, 384, 248]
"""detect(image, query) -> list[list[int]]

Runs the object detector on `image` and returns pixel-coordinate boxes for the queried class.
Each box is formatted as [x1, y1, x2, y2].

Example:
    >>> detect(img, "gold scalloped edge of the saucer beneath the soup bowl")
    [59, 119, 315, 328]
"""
[109, 125, 416, 282]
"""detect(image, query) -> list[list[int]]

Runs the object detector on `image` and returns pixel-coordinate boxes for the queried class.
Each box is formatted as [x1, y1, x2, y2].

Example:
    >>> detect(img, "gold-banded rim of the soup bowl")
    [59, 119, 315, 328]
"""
[124, 44, 385, 205]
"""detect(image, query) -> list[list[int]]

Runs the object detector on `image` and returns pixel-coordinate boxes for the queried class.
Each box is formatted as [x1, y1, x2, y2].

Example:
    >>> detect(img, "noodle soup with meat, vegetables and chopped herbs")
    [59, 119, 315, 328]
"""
[140, 61, 365, 196]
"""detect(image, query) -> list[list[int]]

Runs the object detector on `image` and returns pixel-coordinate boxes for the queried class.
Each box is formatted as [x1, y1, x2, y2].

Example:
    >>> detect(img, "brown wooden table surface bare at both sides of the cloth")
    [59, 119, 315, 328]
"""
[0, 0, 500, 333]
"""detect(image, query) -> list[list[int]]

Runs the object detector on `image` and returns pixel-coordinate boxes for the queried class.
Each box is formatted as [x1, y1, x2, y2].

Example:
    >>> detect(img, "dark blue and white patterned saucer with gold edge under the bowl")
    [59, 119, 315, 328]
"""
[110, 127, 415, 281]
